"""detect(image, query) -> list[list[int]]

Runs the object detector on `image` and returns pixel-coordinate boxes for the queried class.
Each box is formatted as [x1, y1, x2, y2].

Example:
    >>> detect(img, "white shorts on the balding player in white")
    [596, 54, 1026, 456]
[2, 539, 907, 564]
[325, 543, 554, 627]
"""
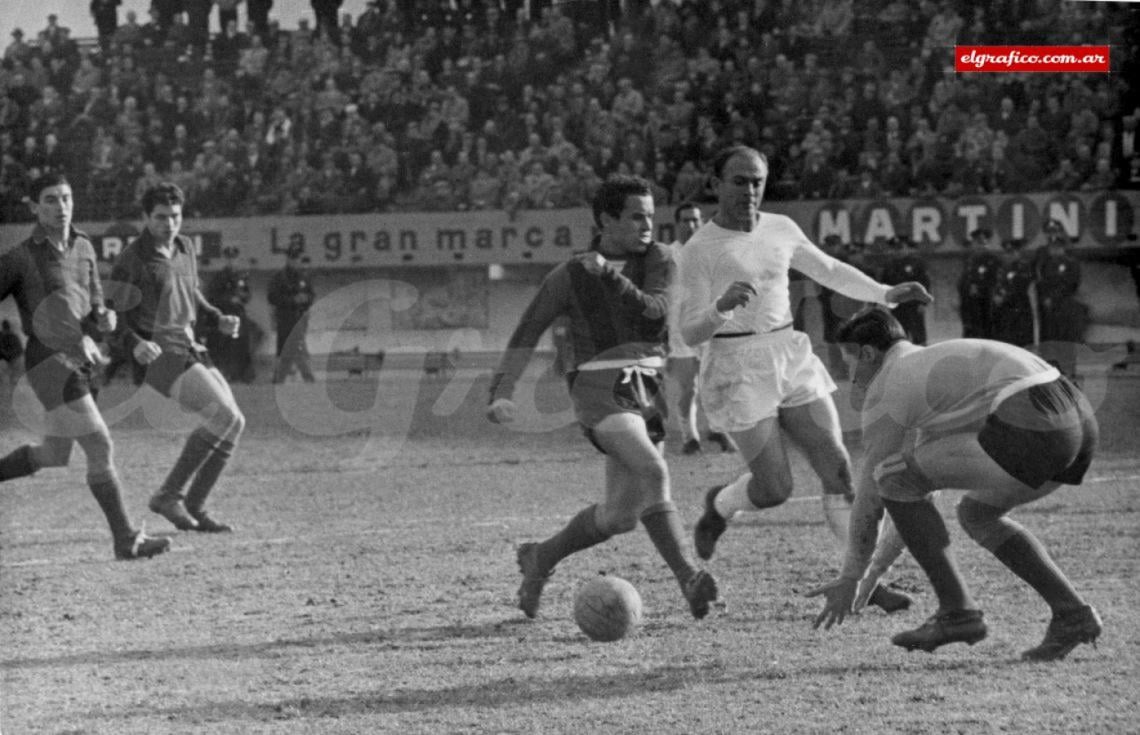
[700, 329, 836, 432]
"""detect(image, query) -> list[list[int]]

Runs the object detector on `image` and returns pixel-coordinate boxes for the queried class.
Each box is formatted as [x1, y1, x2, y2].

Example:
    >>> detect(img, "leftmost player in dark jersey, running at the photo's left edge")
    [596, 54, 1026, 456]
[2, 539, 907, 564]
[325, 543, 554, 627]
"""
[0, 174, 170, 560]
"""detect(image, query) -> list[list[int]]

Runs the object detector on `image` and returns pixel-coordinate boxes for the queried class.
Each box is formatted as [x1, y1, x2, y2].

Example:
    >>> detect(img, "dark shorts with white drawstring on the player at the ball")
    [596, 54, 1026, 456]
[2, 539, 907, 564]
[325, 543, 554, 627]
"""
[567, 368, 668, 454]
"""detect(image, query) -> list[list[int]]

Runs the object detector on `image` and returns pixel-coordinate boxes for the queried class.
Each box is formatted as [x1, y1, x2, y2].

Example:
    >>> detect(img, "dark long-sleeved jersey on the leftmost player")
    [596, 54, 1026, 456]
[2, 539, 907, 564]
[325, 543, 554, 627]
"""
[0, 226, 103, 367]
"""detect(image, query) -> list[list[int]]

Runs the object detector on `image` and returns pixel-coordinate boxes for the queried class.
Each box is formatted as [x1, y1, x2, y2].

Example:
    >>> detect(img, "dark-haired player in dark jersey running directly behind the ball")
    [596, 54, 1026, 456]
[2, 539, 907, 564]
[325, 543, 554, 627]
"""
[487, 177, 717, 619]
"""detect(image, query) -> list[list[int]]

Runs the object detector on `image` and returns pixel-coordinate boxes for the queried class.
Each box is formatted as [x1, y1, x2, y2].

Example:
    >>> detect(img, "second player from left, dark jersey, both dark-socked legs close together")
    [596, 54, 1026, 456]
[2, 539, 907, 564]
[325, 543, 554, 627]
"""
[107, 183, 245, 533]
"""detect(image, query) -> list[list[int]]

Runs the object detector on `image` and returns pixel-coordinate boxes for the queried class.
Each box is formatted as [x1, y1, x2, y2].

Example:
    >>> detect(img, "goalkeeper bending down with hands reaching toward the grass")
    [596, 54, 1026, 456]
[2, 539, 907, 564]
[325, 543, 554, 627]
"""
[808, 309, 1101, 661]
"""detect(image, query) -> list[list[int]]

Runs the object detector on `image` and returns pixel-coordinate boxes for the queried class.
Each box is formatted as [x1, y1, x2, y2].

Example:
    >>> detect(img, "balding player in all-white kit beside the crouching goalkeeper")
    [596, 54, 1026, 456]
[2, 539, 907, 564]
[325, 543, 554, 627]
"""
[678, 146, 931, 612]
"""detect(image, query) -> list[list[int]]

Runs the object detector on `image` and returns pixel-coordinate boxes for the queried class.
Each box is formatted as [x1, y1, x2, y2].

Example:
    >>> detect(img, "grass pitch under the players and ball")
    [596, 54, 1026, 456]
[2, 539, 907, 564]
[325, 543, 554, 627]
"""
[0, 353, 1140, 735]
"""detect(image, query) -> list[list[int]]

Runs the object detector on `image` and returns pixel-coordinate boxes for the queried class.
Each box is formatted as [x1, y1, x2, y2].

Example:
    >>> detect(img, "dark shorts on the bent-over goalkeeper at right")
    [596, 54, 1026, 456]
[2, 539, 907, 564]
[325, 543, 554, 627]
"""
[978, 377, 1100, 488]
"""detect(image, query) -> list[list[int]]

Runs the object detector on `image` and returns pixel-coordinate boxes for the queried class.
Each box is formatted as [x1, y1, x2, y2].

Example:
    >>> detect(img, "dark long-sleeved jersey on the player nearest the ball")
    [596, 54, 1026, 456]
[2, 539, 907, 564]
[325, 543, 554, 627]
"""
[490, 243, 674, 401]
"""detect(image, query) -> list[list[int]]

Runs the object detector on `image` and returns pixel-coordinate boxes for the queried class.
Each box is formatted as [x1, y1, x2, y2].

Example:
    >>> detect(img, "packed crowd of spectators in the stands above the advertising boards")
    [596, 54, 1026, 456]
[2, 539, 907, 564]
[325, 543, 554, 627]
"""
[0, 0, 1140, 221]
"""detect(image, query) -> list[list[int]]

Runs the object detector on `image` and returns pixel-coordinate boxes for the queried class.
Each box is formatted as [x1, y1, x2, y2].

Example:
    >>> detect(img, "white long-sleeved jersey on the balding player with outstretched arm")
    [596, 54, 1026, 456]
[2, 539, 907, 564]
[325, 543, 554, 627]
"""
[677, 212, 890, 345]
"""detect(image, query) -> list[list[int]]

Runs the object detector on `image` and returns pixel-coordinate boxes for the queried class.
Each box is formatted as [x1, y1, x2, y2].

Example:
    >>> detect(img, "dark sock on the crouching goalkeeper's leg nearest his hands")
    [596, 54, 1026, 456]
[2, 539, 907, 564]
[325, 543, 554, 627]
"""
[882, 498, 972, 611]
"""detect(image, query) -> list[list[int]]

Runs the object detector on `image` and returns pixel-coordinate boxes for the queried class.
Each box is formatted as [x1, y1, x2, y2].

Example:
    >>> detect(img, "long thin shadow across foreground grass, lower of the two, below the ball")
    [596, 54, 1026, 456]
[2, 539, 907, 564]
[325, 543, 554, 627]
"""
[91, 660, 1017, 722]
